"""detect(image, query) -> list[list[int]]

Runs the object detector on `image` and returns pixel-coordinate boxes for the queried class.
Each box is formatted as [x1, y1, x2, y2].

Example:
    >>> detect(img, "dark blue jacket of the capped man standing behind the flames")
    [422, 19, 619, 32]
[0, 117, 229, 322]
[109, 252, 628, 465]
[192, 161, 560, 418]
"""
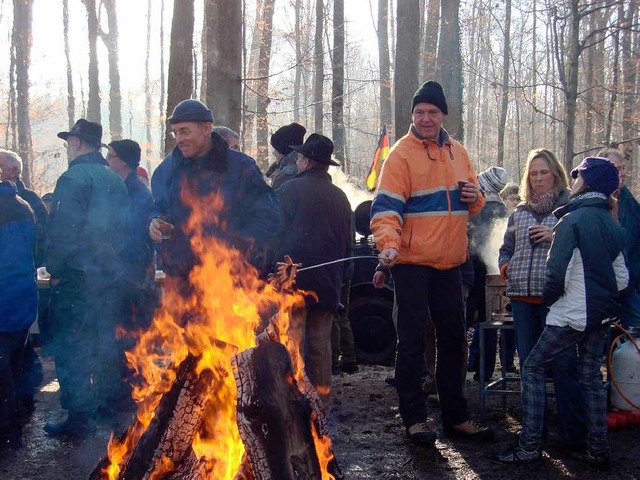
[151, 133, 280, 276]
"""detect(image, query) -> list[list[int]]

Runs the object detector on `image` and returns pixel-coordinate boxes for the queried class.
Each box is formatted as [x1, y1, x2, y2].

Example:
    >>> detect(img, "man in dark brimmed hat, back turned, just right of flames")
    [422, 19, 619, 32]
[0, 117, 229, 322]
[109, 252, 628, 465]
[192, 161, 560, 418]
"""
[276, 133, 353, 406]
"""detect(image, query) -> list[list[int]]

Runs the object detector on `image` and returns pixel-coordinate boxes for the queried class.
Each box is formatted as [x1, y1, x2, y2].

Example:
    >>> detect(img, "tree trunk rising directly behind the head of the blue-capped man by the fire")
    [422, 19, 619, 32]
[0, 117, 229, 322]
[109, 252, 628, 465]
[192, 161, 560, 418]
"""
[164, 0, 194, 154]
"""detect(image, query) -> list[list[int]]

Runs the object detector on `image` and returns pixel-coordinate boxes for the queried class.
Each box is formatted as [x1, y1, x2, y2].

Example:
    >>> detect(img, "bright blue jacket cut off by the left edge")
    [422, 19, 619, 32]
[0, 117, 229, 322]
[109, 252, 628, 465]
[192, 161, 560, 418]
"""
[0, 182, 38, 332]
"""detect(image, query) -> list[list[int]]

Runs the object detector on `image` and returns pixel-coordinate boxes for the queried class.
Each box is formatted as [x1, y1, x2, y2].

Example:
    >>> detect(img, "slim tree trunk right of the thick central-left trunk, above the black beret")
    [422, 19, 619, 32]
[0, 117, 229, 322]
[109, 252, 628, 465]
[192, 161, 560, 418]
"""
[256, 0, 275, 171]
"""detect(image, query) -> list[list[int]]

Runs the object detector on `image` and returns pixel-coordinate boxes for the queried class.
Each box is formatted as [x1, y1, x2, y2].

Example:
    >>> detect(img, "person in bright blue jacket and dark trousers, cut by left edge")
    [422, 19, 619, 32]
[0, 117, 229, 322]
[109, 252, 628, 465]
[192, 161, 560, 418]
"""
[0, 182, 38, 449]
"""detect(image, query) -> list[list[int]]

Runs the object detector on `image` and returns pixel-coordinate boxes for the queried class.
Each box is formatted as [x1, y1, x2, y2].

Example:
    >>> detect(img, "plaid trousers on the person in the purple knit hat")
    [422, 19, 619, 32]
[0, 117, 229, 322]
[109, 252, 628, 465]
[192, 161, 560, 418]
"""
[519, 326, 608, 455]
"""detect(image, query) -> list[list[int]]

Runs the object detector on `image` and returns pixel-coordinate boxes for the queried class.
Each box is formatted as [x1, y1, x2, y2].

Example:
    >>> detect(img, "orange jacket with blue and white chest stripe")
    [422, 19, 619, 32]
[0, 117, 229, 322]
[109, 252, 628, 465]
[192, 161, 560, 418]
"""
[371, 129, 485, 270]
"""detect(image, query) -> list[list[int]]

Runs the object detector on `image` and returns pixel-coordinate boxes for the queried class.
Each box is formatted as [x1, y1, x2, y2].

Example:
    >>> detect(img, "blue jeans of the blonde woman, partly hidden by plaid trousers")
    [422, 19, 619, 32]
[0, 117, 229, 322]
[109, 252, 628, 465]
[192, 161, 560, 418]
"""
[511, 300, 587, 442]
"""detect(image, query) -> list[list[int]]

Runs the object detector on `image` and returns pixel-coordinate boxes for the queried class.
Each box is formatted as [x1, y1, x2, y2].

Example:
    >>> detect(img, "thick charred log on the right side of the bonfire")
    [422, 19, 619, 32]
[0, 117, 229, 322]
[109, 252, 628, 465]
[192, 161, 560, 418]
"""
[234, 342, 342, 480]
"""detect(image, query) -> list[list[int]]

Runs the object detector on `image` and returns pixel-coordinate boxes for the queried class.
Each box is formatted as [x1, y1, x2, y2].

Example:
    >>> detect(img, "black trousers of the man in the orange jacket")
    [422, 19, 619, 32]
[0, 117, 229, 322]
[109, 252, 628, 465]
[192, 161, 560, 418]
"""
[393, 265, 468, 427]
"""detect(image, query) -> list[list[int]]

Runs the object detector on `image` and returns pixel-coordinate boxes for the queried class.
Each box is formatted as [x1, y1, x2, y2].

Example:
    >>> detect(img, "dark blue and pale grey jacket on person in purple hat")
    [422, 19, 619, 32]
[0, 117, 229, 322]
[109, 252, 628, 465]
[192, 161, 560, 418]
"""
[542, 192, 629, 331]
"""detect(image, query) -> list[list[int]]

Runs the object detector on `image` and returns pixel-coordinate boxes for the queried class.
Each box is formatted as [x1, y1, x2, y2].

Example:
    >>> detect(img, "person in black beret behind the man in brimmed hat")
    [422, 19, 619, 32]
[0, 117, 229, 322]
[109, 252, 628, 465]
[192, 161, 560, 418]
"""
[266, 122, 307, 189]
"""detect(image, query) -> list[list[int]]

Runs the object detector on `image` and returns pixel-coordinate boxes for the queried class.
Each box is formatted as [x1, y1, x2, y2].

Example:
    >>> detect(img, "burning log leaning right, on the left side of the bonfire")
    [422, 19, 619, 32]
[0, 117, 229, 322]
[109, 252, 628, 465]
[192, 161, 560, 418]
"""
[89, 355, 216, 480]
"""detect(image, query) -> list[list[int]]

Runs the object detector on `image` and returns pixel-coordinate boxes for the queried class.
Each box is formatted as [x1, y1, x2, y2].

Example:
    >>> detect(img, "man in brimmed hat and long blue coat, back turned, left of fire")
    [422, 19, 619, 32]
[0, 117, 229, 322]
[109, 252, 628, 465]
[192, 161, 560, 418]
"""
[45, 119, 129, 437]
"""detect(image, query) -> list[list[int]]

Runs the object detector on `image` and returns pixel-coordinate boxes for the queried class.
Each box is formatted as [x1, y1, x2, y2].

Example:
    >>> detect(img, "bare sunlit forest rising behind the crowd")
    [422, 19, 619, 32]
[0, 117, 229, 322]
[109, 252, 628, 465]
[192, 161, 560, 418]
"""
[0, 0, 640, 194]
